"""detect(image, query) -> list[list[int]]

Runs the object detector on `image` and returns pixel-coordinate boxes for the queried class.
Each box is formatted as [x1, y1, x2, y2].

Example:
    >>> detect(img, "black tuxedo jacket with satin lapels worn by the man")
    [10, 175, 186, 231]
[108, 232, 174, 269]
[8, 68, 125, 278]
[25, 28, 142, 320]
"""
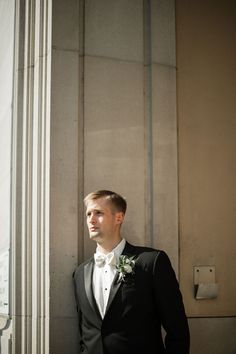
[74, 242, 189, 354]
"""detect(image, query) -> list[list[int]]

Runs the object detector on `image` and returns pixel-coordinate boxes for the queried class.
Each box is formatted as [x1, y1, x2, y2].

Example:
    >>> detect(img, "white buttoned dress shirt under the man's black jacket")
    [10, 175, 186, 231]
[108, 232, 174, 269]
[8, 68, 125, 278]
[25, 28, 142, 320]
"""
[93, 239, 126, 318]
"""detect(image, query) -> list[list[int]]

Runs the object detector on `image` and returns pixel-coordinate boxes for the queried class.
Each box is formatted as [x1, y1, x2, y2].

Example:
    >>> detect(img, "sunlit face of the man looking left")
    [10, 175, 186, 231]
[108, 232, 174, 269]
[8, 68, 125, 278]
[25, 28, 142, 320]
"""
[86, 198, 124, 244]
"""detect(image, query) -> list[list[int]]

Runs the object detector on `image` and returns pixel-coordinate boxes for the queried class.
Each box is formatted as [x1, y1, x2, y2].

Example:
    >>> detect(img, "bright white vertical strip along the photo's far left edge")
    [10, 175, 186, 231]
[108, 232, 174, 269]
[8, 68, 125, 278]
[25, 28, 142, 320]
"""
[0, 0, 15, 354]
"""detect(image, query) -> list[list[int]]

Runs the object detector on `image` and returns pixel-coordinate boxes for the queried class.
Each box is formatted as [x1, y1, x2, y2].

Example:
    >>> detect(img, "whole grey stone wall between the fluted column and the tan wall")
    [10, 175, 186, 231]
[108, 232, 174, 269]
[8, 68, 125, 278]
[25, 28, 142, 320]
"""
[50, 0, 178, 354]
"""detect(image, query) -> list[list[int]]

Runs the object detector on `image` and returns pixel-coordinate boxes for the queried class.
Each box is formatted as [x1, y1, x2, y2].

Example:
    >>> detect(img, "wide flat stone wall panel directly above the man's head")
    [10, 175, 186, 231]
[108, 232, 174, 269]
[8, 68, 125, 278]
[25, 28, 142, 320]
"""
[84, 0, 146, 257]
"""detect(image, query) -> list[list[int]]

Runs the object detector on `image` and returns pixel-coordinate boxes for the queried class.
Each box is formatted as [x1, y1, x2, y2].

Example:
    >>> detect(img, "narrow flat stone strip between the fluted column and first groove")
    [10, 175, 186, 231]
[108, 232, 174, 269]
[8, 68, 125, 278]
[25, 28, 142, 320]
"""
[49, 0, 80, 354]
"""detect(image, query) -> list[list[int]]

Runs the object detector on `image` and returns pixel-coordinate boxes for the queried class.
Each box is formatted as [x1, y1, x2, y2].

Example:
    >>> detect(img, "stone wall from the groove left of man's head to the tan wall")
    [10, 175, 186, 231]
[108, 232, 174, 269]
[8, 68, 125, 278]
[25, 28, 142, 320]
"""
[84, 0, 178, 270]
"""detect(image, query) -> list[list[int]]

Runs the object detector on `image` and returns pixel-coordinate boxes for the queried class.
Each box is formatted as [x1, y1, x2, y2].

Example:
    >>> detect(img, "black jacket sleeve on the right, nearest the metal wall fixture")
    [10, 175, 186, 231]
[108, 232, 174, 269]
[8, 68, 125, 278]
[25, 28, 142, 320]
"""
[153, 251, 190, 354]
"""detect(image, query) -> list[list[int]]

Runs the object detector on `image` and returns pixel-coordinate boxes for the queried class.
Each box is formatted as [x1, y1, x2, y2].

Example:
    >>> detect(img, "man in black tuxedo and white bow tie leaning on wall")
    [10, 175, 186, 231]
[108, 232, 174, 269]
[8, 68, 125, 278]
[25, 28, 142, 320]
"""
[74, 190, 189, 354]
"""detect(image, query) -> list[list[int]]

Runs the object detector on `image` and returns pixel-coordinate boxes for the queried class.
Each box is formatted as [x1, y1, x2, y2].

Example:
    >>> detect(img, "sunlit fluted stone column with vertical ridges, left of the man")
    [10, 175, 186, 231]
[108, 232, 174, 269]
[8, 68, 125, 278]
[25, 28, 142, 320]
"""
[11, 0, 51, 354]
